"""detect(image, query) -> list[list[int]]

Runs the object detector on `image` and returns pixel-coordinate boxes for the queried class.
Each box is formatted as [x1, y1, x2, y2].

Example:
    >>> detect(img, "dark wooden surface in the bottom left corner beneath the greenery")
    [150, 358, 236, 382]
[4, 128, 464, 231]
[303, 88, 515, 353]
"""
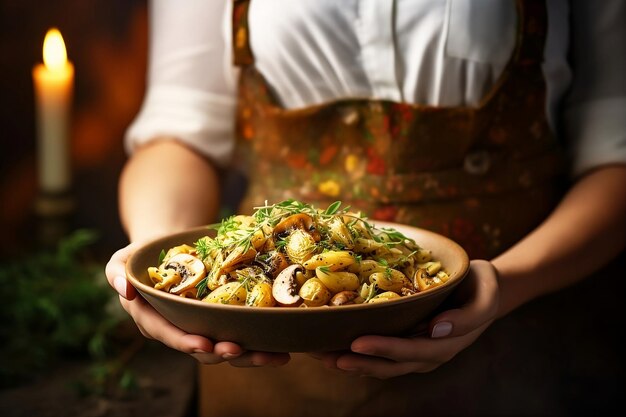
[0, 342, 197, 417]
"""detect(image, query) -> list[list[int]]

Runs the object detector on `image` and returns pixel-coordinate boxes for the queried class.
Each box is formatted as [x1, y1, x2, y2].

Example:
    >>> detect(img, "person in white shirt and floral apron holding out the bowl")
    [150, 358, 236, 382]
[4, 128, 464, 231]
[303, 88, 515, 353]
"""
[107, 0, 626, 415]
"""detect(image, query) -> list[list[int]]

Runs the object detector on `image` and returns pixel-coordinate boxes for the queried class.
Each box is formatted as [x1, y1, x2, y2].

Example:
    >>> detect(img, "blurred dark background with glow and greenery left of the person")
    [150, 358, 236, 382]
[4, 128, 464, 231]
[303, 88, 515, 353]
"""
[0, 0, 196, 416]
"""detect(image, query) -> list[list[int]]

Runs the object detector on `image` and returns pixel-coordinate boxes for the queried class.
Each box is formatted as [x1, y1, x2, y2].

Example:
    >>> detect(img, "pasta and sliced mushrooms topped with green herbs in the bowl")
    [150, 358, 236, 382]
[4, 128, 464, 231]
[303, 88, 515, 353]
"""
[147, 200, 450, 307]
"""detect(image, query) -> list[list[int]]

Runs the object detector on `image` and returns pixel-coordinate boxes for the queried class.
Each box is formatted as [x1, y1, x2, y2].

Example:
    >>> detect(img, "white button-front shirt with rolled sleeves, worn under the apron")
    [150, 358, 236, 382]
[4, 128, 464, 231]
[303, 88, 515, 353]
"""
[126, 0, 626, 175]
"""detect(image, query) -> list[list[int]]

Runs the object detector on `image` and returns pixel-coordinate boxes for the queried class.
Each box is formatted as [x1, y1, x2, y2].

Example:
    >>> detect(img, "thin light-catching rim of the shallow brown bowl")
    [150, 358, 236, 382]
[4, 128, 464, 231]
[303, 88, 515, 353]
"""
[125, 220, 470, 314]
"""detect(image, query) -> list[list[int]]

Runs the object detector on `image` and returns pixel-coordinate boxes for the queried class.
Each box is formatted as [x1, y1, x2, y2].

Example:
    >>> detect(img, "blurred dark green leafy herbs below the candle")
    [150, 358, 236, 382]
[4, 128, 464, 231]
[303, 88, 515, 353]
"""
[0, 229, 122, 388]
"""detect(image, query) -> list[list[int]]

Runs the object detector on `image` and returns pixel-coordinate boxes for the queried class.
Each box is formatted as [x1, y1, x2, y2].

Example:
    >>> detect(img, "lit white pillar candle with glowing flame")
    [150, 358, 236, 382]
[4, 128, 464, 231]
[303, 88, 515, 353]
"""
[33, 28, 74, 194]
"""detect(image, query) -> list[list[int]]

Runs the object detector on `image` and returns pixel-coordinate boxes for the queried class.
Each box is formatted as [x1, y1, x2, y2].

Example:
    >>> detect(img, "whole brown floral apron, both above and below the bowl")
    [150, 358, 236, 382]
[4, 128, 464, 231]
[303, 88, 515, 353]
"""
[199, 0, 563, 416]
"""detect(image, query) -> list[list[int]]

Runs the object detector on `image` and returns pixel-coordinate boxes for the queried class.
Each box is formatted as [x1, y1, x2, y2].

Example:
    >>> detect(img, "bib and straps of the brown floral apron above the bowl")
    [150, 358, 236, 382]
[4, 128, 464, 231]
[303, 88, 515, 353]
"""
[233, 1, 562, 258]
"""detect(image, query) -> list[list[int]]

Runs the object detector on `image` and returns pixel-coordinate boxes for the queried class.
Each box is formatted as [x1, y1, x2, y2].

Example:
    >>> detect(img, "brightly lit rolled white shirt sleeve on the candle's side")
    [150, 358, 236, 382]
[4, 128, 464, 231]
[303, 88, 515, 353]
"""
[124, 0, 237, 166]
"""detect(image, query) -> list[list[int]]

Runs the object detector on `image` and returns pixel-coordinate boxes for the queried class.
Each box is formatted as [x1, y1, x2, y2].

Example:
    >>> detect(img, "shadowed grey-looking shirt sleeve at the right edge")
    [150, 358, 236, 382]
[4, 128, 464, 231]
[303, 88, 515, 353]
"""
[563, 0, 626, 176]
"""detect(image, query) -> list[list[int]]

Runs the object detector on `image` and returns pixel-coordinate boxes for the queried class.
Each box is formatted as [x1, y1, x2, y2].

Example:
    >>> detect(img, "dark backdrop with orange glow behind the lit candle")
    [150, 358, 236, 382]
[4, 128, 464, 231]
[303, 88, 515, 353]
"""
[0, 0, 147, 259]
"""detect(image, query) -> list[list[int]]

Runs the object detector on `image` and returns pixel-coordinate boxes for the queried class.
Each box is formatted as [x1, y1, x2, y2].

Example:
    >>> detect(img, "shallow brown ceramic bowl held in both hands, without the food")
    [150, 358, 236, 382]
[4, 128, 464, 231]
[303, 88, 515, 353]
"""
[126, 221, 469, 352]
